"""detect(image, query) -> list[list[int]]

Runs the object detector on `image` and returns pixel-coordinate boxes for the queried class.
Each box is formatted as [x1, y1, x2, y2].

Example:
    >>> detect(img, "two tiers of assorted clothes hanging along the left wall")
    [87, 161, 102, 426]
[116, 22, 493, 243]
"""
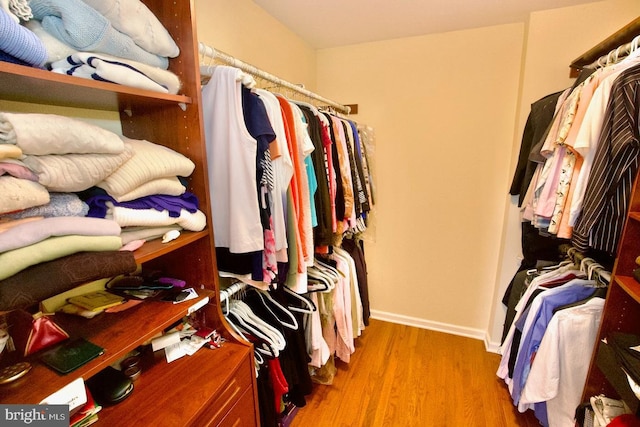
[203, 61, 373, 418]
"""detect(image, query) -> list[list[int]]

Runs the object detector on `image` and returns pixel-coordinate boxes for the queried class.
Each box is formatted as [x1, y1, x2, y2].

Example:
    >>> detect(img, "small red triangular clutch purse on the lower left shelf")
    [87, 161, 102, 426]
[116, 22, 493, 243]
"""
[9, 310, 69, 356]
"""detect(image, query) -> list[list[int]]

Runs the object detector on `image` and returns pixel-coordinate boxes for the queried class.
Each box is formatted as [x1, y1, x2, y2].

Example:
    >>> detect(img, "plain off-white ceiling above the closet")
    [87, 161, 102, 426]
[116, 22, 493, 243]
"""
[253, 0, 597, 49]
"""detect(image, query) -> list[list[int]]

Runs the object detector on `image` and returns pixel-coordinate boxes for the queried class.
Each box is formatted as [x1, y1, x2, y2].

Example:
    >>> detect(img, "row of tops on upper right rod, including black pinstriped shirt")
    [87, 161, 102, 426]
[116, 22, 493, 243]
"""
[510, 51, 640, 255]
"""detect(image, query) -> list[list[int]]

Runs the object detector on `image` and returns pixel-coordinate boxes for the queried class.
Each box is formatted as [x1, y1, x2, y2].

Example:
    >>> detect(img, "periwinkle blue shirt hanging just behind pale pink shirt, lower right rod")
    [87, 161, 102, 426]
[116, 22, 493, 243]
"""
[511, 279, 595, 405]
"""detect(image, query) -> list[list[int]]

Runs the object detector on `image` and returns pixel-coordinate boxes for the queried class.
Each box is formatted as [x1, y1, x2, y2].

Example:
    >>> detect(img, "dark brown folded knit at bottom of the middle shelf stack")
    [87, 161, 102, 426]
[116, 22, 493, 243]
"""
[0, 251, 136, 311]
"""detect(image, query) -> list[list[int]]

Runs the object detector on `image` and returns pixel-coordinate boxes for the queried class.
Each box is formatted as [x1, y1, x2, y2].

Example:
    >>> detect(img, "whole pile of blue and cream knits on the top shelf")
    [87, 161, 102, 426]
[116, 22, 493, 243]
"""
[0, 0, 181, 94]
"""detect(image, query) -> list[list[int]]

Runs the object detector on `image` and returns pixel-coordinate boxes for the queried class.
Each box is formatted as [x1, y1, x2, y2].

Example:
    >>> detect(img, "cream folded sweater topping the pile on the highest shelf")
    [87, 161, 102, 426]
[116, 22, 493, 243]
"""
[82, 0, 180, 58]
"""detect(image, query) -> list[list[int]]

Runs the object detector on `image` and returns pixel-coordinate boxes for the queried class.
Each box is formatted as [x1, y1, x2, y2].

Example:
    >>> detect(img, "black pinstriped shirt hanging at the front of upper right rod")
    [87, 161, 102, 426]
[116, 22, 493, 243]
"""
[572, 65, 640, 255]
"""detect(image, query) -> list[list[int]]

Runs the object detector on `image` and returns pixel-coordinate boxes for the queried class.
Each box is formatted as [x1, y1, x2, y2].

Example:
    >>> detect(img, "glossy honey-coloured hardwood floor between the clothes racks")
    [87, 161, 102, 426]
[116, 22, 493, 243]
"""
[290, 319, 539, 427]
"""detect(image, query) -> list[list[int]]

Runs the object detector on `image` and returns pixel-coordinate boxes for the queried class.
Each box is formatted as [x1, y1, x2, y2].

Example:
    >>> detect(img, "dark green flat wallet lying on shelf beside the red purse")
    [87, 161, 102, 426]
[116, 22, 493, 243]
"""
[40, 338, 104, 374]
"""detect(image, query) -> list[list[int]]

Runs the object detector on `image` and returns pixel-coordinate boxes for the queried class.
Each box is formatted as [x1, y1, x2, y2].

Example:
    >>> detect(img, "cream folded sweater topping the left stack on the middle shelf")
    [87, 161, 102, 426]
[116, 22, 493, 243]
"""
[0, 113, 124, 155]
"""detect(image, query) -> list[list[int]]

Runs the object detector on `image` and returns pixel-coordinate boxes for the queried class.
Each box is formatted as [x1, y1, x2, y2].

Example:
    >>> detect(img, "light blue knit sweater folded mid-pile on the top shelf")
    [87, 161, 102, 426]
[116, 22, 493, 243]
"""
[29, 0, 169, 70]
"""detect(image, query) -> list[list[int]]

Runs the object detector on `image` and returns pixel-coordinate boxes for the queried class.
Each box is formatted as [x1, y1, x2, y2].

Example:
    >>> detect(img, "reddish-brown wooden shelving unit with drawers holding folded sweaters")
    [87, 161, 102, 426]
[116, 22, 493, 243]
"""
[0, 0, 259, 426]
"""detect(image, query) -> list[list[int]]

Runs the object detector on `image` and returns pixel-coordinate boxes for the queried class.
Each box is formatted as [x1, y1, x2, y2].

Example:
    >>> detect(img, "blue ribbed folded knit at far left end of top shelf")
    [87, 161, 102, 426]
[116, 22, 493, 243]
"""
[0, 8, 47, 67]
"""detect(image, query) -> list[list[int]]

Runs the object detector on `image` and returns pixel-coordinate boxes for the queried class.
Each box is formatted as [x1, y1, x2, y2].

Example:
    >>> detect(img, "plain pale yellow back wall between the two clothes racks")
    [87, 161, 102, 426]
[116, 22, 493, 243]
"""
[318, 24, 524, 338]
